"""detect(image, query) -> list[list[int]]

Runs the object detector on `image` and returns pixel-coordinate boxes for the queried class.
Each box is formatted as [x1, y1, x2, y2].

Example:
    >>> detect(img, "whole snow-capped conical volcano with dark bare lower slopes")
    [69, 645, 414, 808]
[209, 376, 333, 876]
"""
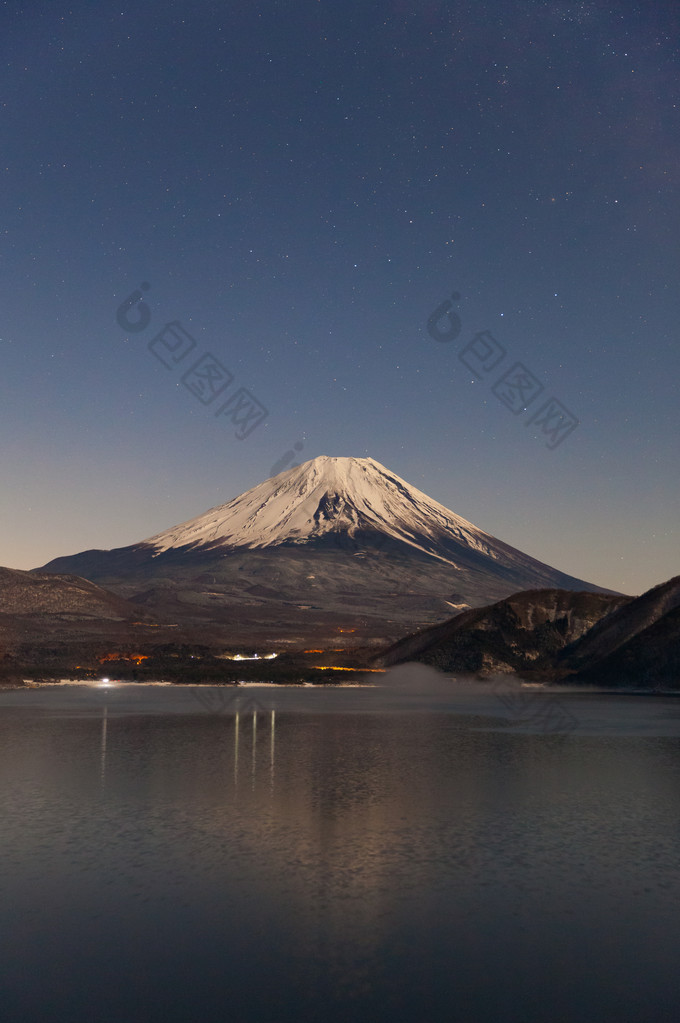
[41, 456, 609, 640]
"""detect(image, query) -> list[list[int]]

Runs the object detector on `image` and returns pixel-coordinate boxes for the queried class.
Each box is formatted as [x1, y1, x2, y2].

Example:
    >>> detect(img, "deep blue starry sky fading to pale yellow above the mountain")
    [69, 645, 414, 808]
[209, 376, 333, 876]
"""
[0, 0, 680, 593]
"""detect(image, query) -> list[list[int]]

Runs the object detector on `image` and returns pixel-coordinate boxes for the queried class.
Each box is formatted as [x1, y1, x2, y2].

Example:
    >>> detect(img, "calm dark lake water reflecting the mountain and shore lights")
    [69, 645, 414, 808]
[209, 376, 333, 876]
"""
[0, 673, 680, 1023]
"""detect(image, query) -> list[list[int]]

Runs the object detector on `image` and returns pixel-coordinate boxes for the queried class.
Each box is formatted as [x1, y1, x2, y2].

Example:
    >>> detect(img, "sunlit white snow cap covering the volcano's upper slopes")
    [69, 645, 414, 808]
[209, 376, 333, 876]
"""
[144, 455, 492, 565]
